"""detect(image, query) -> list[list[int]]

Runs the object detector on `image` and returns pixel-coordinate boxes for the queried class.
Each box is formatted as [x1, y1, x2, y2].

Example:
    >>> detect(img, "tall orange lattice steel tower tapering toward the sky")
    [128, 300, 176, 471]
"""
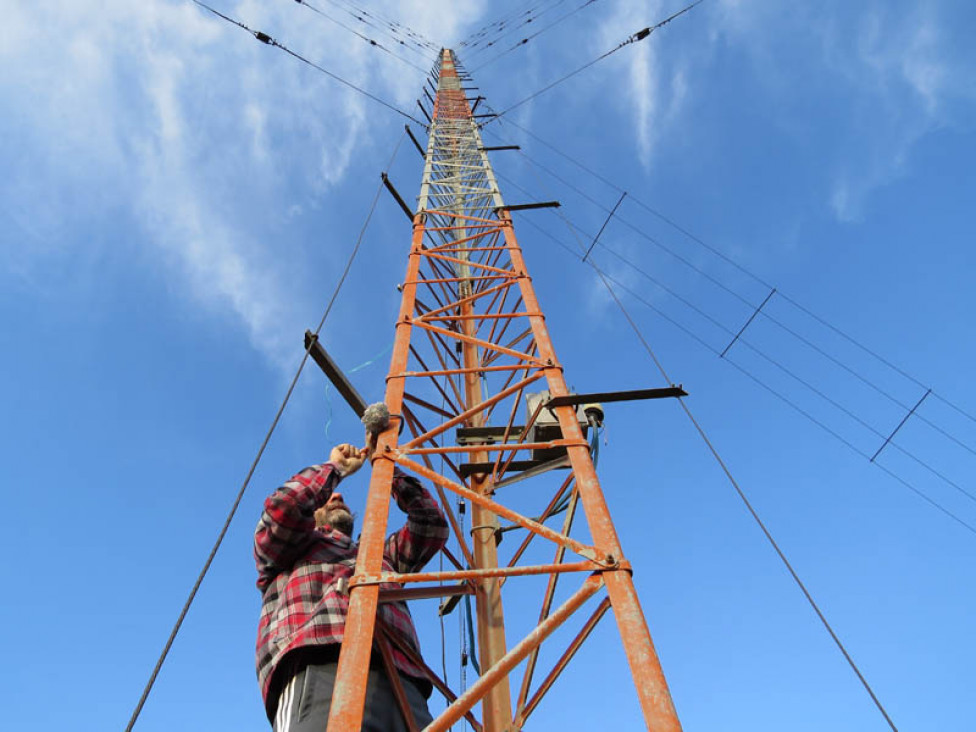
[329, 50, 680, 732]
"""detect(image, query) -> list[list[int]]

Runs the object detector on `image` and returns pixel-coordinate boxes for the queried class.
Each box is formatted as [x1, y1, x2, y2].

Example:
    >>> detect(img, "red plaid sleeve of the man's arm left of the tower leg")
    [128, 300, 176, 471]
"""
[254, 463, 340, 592]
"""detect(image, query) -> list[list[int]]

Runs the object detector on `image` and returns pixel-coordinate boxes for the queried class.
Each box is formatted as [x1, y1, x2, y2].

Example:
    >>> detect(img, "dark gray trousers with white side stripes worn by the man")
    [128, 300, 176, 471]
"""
[274, 661, 433, 732]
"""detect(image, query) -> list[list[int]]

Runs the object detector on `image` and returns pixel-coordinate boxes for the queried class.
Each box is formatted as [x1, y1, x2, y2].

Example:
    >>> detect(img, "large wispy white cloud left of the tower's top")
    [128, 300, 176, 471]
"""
[0, 0, 484, 363]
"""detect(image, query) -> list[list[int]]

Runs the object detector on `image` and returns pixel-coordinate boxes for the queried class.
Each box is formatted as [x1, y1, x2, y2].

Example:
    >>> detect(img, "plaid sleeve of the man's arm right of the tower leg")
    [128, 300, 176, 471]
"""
[386, 469, 447, 574]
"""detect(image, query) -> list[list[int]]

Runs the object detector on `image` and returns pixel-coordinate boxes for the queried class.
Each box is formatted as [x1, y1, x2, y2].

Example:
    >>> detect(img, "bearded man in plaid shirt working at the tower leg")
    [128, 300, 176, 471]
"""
[254, 440, 447, 732]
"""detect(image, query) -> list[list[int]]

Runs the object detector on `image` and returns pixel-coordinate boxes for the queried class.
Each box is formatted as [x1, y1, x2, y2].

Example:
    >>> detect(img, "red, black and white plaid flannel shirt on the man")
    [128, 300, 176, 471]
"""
[254, 463, 447, 718]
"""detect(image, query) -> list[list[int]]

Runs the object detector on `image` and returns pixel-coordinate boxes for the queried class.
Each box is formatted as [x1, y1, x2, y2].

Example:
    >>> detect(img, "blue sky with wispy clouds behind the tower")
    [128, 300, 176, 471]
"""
[0, 0, 976, 732]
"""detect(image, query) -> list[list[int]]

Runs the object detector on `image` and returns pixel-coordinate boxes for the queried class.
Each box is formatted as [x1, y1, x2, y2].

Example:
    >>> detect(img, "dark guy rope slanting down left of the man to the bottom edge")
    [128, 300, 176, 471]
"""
[125, 132, 406, 732]
